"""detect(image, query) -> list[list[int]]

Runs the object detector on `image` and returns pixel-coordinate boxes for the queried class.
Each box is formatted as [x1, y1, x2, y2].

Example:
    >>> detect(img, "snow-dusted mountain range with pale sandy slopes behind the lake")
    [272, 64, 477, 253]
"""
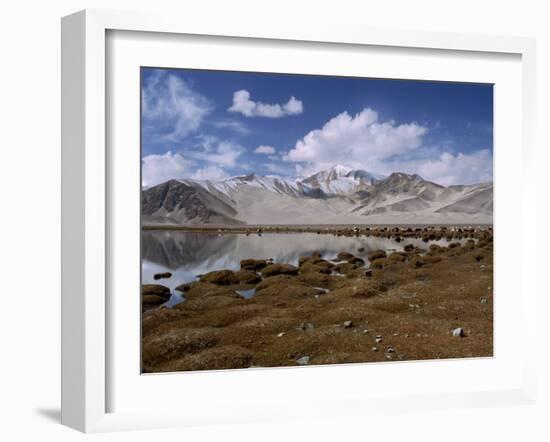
[141, 165, 493, 225]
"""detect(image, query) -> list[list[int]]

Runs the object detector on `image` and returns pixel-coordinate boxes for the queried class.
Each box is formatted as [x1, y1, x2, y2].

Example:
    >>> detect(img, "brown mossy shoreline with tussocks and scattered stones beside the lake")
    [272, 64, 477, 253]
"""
[142, 226, 493, 373]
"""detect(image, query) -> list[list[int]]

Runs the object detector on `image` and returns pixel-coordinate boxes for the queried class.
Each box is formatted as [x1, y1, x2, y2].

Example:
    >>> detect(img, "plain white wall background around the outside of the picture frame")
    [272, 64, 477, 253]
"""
[0, 0, 550, 441]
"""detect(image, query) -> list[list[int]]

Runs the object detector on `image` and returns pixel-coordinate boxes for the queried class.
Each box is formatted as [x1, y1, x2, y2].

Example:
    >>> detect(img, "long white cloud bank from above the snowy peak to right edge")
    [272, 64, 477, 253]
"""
[283, 108, 493, 185]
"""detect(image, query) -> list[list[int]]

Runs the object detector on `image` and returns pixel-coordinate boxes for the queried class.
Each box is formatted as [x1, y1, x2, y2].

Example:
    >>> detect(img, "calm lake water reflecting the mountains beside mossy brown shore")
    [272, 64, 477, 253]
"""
[141, 231, 462, 306]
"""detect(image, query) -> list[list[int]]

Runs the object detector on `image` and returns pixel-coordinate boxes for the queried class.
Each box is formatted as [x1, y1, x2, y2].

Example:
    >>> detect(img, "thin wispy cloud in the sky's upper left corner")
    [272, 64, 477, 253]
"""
[141, 70, 212, 141]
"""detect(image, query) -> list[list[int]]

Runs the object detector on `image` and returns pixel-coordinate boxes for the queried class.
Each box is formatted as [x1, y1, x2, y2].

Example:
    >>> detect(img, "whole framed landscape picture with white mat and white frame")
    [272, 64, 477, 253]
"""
[62, 11, 536, 431]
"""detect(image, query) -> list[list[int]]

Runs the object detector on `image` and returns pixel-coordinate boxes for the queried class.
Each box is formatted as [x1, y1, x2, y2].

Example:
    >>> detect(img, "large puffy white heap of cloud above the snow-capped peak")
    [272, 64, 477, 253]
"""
[284, 108, 427, 170]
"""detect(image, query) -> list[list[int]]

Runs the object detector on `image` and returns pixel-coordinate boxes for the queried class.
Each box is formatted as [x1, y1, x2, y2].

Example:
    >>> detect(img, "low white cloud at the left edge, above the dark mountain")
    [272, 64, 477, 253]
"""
[141, 151, 193, 186]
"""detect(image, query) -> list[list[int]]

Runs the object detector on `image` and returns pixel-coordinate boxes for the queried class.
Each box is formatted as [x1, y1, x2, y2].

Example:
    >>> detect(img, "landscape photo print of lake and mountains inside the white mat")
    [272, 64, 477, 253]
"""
[140, 67, 493, 373]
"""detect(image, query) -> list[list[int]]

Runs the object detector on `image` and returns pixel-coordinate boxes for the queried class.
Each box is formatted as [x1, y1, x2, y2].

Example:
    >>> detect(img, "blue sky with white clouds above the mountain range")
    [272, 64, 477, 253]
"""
[141, 68, 493, 185]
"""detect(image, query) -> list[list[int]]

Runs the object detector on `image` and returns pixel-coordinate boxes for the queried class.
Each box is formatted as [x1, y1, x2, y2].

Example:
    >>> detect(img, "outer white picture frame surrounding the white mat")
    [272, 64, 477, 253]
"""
[62, 10, 537, 432]
